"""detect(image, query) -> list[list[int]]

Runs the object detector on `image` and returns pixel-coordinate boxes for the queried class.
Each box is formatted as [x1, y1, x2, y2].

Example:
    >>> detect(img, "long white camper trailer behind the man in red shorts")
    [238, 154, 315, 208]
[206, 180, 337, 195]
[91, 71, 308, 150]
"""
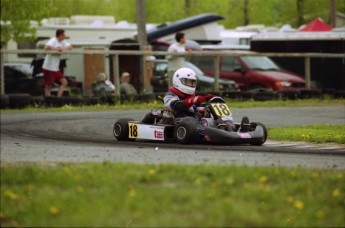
[5, 15, 140, 63]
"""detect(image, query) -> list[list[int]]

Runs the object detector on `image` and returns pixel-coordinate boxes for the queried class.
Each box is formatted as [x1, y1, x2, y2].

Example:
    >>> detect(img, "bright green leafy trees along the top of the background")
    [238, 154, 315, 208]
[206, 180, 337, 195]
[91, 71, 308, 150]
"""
[1, 0, 345, 43]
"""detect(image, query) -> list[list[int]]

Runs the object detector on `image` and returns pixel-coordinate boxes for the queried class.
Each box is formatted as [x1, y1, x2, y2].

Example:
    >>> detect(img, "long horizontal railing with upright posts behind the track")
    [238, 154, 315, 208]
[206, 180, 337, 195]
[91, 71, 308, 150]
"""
[1, 49, 345, 95]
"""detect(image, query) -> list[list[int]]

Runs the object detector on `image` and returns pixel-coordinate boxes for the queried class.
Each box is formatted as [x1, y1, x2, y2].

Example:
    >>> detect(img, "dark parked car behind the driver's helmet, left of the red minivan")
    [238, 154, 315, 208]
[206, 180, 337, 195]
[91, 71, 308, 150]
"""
[151, 59, 239, 93]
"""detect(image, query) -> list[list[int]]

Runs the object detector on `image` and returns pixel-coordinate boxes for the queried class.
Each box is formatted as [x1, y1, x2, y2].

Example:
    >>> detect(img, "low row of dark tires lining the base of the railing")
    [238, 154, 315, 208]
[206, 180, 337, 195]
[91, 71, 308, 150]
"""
[0, 89, 345, 109]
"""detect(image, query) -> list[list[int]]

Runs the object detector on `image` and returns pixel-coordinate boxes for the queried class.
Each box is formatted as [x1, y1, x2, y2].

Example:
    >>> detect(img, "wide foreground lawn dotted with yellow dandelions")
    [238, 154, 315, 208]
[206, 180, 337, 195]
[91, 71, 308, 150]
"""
[0, 162, 345, 227]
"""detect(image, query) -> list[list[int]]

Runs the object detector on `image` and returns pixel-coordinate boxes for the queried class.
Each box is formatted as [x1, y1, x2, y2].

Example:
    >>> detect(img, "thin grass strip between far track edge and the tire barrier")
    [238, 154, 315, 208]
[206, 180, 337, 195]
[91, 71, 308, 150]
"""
[1, 98, 345, 113]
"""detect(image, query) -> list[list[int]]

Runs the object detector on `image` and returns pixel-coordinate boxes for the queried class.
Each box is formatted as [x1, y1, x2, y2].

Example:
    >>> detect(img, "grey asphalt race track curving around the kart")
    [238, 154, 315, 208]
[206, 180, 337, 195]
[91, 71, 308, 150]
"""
[1, 106, 345, 169]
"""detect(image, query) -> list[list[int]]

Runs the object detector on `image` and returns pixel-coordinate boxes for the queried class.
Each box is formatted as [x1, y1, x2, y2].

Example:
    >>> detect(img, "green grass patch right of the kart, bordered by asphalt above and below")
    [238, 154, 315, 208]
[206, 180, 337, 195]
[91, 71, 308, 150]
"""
[268, 125, 345, 144]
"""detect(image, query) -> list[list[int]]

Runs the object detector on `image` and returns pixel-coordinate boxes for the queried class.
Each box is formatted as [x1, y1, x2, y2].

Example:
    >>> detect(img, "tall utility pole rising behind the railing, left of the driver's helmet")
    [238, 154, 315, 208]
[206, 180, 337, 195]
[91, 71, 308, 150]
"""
[136, 0, 152, 93]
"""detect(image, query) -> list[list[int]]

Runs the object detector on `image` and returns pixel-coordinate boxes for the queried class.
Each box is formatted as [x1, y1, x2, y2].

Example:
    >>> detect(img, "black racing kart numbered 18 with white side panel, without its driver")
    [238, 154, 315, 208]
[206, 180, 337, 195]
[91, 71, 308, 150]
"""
[113, 97, 267, 146]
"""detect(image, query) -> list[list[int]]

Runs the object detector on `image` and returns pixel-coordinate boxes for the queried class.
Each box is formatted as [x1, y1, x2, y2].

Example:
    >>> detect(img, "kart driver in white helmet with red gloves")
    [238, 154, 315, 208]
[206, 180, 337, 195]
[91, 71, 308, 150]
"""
[163, 67, 214, 118]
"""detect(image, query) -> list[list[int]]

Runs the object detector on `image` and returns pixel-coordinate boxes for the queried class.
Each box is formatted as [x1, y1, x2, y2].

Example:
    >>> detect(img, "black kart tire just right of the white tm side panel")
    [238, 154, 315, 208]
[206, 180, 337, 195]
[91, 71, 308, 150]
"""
[174, 121, 197, 144]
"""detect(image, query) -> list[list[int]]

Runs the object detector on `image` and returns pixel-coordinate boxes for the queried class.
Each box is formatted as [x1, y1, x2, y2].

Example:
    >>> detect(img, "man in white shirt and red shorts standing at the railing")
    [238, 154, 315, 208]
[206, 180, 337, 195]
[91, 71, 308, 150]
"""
[42, 29, 72, 97]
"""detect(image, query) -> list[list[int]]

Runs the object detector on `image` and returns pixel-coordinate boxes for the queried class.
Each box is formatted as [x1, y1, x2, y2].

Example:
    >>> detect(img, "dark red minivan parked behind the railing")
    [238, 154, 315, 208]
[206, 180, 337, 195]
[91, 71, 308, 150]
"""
[189, 45, 305, 91]
